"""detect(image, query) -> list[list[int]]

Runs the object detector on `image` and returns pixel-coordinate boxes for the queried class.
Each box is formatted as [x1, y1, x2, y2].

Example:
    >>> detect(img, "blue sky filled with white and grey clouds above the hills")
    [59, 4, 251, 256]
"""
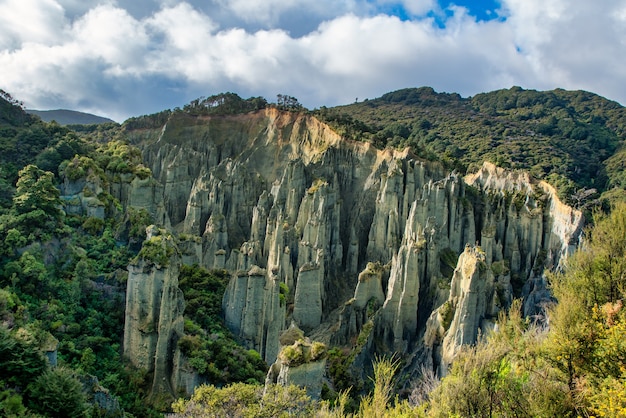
[0, 0, 626, 122]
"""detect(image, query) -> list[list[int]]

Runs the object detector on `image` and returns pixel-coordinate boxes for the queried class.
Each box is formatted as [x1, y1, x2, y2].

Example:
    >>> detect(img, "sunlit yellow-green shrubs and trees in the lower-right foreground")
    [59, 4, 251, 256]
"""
[174, 204, 626, 417]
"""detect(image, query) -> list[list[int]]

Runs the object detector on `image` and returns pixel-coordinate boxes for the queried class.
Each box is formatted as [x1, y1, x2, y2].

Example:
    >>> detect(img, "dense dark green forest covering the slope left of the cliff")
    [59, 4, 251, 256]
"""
[0, 95, 161, 416]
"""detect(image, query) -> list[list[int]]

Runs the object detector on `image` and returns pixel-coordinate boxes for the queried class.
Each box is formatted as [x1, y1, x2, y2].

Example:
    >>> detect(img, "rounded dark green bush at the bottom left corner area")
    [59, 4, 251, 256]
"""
[28, 368, 88, 417]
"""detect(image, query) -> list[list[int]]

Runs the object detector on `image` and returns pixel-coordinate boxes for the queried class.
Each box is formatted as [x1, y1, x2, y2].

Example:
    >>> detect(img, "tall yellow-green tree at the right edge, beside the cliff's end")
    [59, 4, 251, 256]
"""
[542, 204, 626, 416]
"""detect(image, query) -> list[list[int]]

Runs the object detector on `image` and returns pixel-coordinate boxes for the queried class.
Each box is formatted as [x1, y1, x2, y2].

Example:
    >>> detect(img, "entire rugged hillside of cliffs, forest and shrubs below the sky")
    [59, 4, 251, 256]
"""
[0, 88, 626, 417]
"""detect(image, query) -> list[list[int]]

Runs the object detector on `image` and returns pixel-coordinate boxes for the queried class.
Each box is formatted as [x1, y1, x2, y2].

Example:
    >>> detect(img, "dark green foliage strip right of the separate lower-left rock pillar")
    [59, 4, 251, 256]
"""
[178, 265, 267, 385]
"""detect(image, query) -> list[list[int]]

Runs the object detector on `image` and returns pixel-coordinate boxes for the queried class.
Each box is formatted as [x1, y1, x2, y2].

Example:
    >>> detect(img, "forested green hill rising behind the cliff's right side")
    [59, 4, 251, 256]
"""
[316, 87, 626, 203]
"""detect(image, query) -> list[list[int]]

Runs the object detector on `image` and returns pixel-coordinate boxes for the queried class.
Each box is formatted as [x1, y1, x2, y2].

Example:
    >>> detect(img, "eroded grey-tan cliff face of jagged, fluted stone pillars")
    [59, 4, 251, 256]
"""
[123, 109, 582, 392]
